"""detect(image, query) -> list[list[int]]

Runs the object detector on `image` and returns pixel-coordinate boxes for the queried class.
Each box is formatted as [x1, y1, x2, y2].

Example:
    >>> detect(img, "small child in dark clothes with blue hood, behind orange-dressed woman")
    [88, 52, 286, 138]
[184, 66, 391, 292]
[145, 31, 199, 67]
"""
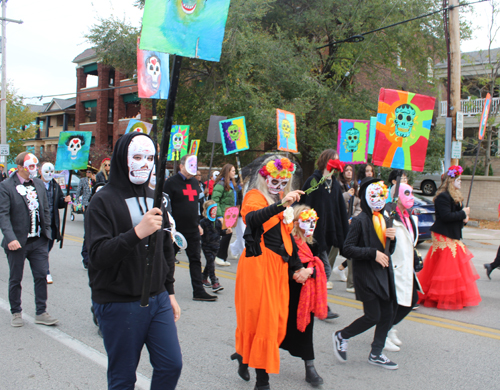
[200, 200, 233, 292]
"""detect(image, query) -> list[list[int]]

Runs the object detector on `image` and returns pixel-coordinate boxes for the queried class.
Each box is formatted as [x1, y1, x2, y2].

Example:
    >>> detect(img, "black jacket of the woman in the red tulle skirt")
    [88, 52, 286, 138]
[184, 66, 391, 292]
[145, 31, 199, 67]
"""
[431, 191, 467, 240]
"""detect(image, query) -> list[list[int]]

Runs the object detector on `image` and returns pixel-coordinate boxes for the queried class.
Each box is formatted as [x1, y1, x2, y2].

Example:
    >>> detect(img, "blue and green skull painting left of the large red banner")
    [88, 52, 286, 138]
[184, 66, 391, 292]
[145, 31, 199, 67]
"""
[337, 119, 370, 164]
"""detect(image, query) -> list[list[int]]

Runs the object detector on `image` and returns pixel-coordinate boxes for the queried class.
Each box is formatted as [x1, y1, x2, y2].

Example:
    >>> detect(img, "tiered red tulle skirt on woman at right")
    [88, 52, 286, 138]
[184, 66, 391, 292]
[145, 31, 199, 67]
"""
[418, 233, 481, 310]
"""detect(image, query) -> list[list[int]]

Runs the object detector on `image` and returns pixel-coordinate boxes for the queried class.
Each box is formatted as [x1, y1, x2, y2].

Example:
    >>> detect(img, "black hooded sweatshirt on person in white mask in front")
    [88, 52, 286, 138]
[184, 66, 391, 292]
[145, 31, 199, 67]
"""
[85, 132, 175, 304]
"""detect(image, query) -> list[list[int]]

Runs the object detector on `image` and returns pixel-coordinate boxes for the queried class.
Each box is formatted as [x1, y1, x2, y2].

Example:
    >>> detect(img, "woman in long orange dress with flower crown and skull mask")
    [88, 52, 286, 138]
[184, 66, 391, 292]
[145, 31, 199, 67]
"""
[231, 156, 311, 390]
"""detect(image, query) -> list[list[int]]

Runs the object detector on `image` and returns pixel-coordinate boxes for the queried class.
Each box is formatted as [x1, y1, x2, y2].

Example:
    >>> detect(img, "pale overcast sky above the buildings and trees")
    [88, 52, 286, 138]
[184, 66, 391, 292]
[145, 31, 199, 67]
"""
[6, 0, 500, 104]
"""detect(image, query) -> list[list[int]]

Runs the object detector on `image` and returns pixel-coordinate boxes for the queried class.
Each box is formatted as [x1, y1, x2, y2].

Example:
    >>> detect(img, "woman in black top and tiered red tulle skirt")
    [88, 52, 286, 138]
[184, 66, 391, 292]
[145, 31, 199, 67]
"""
[418, 165, 481, 310]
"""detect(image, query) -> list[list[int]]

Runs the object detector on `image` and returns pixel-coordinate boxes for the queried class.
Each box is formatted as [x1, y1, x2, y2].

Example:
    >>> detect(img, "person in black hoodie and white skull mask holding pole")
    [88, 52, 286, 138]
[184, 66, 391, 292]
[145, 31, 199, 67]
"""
[85, 132, 182, 389]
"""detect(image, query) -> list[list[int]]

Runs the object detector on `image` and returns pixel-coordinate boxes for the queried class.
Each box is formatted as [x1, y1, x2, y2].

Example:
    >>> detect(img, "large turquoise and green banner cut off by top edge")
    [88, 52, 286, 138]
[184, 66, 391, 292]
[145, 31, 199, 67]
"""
[141, 0, 230, 62]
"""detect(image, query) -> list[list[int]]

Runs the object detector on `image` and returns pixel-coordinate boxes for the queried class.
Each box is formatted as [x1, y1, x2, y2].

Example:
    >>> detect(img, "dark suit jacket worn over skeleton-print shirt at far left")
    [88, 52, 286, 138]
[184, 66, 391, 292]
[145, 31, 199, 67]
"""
[0, 173, 51, 249]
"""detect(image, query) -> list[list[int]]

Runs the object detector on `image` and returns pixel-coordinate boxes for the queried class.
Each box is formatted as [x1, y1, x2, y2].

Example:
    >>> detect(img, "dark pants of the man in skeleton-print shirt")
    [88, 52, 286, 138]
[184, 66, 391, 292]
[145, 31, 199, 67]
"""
[5, 237, 49, 315]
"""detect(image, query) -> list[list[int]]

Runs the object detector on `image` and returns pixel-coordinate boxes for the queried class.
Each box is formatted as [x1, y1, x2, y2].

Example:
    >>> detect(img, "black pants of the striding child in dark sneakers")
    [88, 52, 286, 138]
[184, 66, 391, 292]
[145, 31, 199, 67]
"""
[340, 298, 394, 356]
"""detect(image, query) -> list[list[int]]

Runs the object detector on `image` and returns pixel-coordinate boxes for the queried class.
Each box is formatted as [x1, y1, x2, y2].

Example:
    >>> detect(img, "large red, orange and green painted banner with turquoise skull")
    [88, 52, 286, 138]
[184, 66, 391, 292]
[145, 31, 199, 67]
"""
[373, 88, 436, 172]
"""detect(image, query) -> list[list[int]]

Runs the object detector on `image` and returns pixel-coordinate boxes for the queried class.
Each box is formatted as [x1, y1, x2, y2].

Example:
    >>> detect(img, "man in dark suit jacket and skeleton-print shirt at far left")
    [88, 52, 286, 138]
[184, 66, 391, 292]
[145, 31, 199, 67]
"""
[0, 152, 58, 327]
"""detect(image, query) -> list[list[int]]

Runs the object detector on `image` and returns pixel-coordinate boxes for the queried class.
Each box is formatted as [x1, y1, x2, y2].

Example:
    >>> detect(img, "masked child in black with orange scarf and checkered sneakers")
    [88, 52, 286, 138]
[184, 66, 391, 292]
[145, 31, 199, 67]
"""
[332, 178, 398, 370]
